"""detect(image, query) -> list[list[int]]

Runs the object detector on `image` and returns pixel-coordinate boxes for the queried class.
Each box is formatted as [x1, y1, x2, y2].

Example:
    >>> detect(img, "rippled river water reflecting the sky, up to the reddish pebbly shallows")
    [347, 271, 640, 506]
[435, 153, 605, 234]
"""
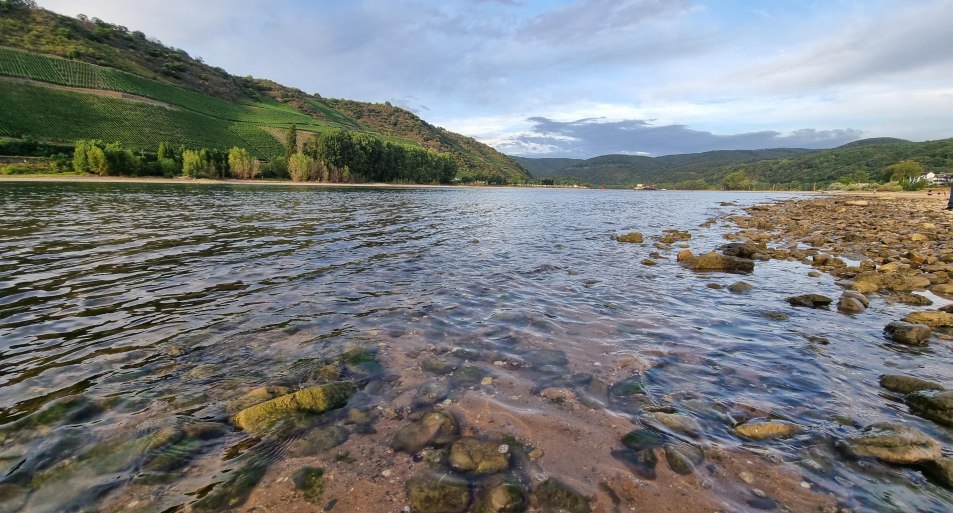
[0, 183, 953, 512]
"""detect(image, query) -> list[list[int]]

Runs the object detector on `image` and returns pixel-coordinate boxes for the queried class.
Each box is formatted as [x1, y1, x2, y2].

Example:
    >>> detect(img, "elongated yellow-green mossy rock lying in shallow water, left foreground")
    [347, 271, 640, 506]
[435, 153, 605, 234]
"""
[233, 381, 357, 433]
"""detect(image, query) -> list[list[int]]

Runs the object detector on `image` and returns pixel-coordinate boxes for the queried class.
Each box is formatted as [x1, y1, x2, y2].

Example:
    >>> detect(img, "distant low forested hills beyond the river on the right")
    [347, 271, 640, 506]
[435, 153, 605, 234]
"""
[517, 137, 953, 189]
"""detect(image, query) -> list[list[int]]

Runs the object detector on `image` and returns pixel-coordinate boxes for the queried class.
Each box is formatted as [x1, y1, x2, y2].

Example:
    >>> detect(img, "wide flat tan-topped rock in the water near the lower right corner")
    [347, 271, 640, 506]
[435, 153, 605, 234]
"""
[838, 422, 940, 465]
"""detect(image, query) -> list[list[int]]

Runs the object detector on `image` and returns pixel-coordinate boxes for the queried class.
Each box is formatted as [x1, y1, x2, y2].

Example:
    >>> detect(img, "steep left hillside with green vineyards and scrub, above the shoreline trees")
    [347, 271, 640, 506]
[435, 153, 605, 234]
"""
[0, 0, 529, 183]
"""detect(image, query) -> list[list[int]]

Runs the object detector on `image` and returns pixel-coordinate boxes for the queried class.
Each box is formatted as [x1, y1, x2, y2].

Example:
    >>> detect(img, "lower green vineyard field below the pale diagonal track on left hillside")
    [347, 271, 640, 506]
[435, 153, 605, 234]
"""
[0, 82, 284, 158]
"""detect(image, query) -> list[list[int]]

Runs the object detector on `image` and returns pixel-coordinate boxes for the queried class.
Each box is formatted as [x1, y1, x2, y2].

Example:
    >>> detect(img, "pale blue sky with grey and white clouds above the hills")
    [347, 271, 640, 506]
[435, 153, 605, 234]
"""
[39, 0, 953, 158]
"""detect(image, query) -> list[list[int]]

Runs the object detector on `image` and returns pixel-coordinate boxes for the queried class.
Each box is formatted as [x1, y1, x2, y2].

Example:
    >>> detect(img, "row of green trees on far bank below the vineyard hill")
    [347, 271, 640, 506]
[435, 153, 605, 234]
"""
[66, 125, 458, 183]
